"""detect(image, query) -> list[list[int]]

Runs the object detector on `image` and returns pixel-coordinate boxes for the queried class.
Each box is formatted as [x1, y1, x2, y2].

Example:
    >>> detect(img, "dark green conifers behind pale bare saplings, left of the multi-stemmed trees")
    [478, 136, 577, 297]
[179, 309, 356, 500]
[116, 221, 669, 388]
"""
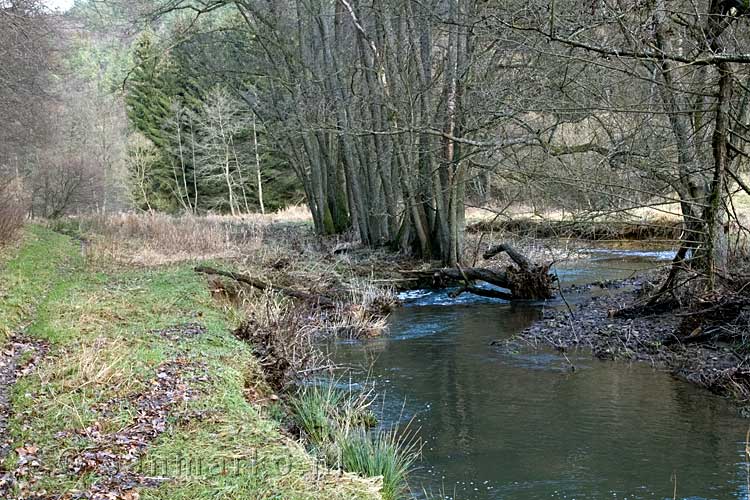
[125, 16, 299, 214]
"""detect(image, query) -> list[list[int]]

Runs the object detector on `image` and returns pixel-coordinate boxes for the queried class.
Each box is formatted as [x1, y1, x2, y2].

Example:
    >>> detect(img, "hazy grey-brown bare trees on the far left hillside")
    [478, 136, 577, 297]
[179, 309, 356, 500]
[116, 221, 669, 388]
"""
[0, 0, 125, 223]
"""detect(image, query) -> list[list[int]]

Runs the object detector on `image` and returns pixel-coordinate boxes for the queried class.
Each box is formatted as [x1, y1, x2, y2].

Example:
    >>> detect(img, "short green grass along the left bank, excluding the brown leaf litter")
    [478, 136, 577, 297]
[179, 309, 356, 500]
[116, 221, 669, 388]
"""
[0, 228, 379, 500]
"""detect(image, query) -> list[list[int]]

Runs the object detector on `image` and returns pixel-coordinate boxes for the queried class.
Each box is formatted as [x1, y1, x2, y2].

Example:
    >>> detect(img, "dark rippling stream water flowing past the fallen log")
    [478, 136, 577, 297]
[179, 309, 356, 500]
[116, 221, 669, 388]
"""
[332, 251, 750, 500]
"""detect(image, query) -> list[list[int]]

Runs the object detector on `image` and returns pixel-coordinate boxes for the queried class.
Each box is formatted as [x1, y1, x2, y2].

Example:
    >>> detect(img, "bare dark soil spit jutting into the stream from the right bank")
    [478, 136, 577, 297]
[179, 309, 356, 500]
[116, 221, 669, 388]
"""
[502, 279, 750, 416]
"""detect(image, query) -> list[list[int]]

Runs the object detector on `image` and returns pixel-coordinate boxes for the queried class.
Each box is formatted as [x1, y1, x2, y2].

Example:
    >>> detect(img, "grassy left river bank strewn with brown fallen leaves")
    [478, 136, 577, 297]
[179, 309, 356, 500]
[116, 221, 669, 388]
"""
[0, 226, 381, 500]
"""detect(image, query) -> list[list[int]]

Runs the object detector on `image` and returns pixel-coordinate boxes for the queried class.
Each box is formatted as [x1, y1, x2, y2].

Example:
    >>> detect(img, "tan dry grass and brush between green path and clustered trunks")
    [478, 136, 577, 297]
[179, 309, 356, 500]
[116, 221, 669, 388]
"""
[71, 207, 396, 344]
